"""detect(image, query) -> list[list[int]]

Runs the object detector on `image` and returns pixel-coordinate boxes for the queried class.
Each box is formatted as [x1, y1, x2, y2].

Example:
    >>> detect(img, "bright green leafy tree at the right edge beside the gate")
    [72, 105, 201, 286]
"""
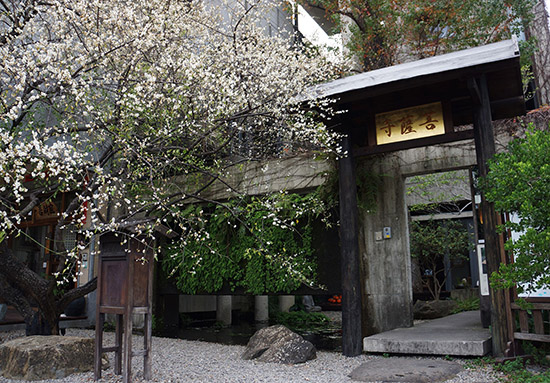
[484, 128, 550, 292]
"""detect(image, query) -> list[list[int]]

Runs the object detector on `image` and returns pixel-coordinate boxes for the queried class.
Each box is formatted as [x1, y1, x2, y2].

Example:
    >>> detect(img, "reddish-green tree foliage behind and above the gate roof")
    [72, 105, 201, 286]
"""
[303, 0, 534, 71]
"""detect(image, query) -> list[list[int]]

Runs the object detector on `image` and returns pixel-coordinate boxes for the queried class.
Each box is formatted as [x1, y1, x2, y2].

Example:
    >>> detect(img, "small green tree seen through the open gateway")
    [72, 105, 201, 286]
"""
[410, 220, 470, 300]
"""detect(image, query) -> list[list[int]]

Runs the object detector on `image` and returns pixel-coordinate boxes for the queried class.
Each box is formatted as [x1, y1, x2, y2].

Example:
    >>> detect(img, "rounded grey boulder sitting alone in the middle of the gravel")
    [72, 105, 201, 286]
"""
[242, 325, 317, 364]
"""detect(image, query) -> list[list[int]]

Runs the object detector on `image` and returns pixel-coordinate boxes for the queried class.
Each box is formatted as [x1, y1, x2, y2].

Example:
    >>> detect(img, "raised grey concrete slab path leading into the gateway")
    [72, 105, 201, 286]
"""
[363, 311, 491, 356]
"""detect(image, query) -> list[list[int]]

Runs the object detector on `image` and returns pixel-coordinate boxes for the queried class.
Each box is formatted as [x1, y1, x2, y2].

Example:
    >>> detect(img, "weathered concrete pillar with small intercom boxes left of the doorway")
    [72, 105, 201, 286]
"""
[357, 155, 413, 335]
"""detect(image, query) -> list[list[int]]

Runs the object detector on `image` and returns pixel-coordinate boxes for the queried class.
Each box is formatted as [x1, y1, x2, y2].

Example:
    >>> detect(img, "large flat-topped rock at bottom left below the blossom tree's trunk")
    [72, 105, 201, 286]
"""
[0, 335, 94, 380]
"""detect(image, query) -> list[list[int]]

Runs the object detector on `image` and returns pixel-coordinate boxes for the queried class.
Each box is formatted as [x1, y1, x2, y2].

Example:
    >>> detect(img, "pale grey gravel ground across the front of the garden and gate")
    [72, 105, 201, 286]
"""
[0, 329, 506, 383]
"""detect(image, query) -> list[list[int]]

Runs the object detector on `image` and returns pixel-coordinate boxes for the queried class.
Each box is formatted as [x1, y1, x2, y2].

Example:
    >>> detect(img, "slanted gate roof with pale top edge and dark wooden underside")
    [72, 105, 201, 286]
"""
[314, 39, 525, 154]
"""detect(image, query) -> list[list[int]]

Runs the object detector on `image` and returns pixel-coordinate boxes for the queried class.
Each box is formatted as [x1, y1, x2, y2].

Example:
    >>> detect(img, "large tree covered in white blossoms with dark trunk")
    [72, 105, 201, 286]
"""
[0, 0, 342, 334]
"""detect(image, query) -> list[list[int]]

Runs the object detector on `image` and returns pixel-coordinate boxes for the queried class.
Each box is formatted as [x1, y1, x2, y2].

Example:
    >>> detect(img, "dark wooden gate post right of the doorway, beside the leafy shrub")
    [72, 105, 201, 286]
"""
[469, 75, 511, 356]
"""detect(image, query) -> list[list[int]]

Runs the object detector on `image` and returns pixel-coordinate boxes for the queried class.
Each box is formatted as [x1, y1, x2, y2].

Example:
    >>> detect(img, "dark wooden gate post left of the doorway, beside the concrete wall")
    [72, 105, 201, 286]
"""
[338, 136, 363, 356]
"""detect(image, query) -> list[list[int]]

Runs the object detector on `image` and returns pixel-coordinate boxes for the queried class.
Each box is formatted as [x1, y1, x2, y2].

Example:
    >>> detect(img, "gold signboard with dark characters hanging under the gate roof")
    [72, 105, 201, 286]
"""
[375, 102, 445, 145]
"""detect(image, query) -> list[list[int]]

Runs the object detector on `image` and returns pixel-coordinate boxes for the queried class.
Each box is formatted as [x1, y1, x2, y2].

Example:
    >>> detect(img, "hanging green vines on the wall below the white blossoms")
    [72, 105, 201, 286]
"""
[162, 193, 334, 294]
